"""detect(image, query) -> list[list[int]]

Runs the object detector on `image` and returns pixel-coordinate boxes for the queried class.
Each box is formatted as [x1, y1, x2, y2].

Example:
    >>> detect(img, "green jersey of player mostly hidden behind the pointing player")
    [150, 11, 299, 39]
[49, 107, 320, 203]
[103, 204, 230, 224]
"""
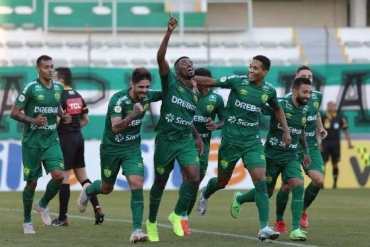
[194, 90, 225, 145]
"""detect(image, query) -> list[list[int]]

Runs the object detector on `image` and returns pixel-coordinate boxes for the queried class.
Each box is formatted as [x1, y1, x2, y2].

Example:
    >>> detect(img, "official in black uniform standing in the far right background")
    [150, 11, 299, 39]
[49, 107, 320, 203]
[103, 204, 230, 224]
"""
[321, 101, 353, 189]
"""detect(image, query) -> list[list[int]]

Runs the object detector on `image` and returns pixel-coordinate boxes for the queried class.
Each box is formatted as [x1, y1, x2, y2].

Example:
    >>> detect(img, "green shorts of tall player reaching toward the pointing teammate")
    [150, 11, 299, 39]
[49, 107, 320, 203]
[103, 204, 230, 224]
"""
[218, 140, 266, 173]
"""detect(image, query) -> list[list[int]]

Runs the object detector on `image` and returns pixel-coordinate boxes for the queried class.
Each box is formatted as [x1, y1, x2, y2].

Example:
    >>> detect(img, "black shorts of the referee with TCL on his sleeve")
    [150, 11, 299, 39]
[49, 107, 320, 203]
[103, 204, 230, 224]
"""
[59, 132, 85, 171]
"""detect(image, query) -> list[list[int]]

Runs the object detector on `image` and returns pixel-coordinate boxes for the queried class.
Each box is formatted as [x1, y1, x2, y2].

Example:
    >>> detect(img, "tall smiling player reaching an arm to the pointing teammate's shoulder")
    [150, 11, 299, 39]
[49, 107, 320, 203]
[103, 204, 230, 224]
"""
[194, 55, 291, 241]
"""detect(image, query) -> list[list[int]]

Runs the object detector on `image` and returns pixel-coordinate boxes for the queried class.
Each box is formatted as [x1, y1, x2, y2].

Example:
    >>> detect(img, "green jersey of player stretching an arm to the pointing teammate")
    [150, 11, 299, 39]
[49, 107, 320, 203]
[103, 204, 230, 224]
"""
[216, 75, 279, 145]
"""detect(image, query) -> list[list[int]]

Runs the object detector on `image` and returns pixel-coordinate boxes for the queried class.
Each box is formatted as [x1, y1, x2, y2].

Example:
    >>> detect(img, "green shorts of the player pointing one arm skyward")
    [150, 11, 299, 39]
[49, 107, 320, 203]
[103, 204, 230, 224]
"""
[154, 135, 199, 177]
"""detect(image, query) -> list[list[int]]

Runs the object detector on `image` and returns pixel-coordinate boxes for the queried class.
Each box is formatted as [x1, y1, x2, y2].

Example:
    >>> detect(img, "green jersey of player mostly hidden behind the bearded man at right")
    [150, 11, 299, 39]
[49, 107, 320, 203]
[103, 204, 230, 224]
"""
[284, 91, 322, 149]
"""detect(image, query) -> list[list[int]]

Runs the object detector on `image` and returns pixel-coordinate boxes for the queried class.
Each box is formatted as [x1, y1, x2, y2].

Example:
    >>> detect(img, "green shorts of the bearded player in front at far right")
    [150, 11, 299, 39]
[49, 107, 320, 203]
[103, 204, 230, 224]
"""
[266, 158, 303, 188]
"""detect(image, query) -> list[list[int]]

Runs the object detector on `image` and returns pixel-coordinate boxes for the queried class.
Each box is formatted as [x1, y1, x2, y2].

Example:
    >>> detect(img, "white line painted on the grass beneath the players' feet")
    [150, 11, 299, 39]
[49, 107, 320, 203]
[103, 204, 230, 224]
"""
[0, 208, 318, 247]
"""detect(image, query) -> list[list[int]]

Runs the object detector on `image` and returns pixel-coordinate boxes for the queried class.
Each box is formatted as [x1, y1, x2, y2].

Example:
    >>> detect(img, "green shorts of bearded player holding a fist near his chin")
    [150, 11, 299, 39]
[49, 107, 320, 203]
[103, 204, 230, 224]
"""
[100, 149, 144, 184]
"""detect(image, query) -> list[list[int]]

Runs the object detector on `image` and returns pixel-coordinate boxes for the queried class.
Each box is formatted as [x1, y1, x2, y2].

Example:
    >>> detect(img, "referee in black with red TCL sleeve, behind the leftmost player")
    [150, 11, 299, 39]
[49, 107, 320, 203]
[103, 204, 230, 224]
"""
[51, 67, 104, 226]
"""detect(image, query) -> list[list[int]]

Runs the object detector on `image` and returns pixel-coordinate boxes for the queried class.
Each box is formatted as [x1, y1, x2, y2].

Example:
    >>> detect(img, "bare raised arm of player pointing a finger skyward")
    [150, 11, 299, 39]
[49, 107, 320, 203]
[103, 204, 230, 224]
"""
[157, 15, 177, 76]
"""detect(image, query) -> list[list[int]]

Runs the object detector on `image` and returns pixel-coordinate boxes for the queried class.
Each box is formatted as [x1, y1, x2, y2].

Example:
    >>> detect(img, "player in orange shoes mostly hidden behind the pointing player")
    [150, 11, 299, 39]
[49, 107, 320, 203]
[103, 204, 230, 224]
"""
[181, 68, 225, 235]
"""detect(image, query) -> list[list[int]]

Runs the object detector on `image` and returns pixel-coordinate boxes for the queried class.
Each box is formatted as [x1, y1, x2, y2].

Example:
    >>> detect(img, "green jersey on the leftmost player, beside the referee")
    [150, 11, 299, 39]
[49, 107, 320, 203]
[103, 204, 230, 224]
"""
[15, 79, 63, 148]
